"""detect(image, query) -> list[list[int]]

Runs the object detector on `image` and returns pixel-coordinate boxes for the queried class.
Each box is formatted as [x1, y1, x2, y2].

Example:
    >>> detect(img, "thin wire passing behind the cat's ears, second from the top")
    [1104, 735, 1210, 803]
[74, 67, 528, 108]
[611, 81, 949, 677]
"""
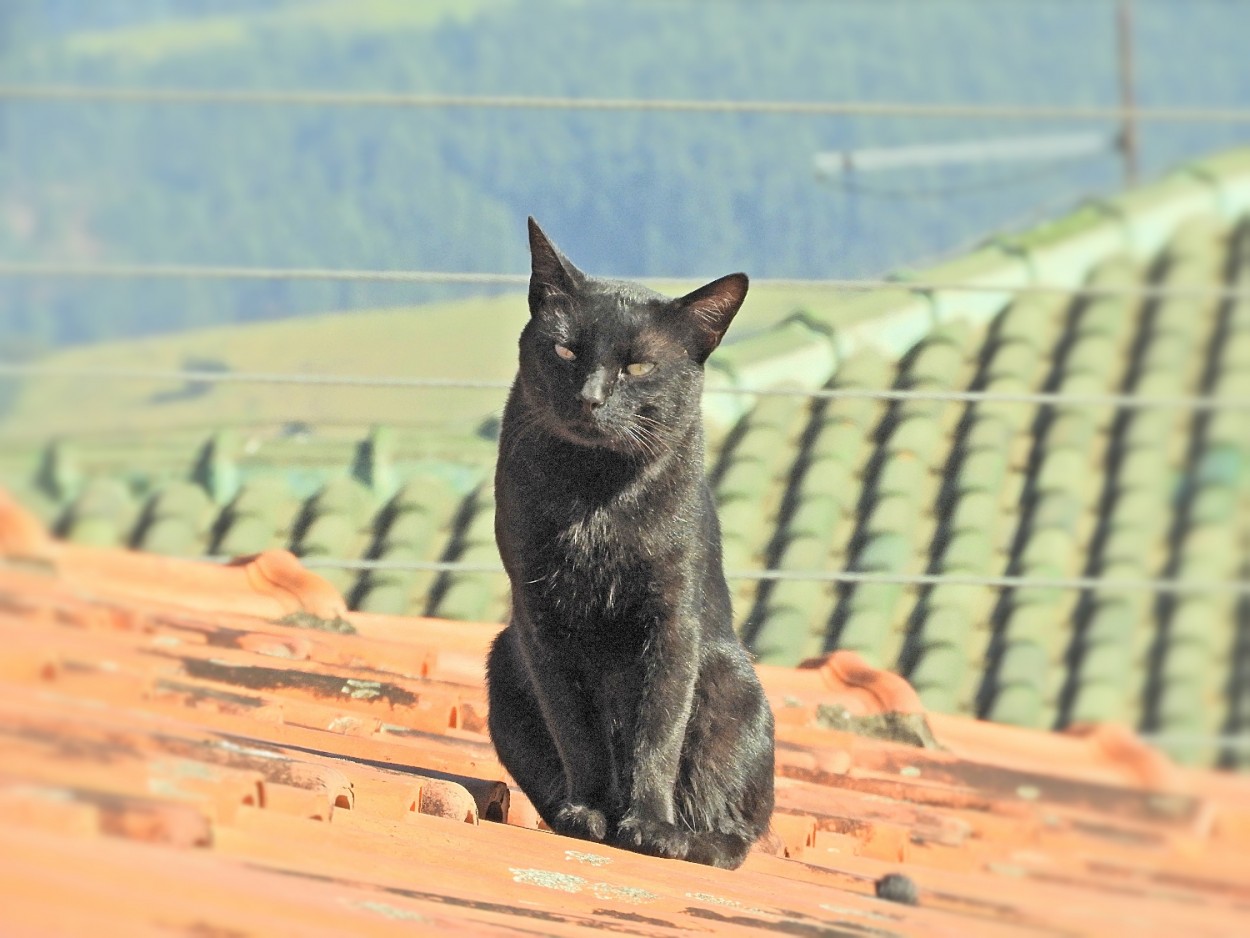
[0, 261, 1250, 300]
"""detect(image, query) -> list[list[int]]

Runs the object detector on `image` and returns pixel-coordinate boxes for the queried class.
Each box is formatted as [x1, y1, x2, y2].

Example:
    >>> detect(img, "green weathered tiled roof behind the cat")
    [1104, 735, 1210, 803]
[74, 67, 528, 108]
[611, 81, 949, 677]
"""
[0, 145, 1250, 768]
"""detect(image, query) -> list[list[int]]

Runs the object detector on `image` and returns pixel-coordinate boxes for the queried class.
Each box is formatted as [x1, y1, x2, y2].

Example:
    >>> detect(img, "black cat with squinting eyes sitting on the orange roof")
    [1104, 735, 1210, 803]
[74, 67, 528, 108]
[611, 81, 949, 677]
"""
[489, 219, 773, 868]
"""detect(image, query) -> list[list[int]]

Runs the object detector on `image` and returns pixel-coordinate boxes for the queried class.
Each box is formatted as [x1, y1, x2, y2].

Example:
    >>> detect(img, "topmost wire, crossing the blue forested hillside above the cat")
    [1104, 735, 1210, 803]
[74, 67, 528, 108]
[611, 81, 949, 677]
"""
[7, 85, 1250, 124]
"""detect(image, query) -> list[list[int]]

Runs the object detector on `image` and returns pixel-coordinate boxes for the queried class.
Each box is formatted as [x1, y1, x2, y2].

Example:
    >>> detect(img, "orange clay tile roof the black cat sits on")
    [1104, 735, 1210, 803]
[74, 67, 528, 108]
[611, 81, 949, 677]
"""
[0, 497, 1250, 937]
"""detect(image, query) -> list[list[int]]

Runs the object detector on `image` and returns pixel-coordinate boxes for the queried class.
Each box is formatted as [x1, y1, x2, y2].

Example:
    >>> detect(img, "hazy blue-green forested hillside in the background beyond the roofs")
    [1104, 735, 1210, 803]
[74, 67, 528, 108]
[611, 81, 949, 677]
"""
[0, 0, 1250, 356]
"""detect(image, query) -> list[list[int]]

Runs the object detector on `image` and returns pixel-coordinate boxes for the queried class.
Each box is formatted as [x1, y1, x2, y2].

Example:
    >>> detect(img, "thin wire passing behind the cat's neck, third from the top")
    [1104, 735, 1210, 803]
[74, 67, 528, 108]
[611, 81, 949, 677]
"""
[0, 363, 1250, 411]
